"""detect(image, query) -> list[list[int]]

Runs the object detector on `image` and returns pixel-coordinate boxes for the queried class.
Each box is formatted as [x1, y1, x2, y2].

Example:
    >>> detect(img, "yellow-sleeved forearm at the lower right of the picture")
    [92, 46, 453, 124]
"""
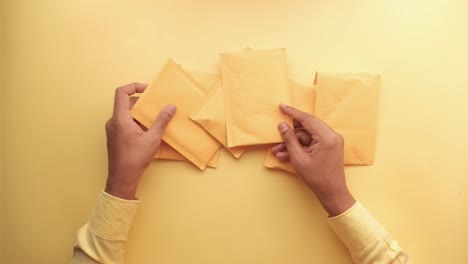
[328, 202, 411, 264]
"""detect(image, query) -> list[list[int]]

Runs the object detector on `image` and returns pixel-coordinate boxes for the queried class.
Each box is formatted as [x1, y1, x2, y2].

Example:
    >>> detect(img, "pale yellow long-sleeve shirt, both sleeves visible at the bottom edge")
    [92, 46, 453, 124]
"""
[72, 191, 411, 264]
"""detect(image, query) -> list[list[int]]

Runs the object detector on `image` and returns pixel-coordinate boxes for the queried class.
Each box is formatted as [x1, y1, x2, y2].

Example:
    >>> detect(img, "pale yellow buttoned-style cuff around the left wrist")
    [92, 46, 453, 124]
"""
[88, 191, 140, 239]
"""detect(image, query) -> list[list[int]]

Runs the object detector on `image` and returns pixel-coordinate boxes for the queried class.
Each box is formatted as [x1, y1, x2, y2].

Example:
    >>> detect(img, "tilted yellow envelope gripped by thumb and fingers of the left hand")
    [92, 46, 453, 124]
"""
[132, 60, 220, 169]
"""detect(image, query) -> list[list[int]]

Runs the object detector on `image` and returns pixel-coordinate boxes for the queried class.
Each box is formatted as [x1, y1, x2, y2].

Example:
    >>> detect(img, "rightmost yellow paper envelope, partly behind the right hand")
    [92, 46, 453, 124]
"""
[315, 72, 380, 165]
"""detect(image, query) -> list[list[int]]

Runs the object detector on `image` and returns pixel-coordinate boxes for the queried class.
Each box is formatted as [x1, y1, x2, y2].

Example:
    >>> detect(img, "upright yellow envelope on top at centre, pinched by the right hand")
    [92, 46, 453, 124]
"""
[221, 49, 292, 147]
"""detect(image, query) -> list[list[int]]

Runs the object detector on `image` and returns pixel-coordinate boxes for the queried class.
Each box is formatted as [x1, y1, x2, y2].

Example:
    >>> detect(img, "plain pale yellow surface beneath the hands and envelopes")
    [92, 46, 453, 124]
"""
[0, 0, 468, 263]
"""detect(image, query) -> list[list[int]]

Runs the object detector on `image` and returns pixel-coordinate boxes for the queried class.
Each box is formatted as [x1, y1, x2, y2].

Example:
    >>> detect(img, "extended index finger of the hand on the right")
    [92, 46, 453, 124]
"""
[280, 104, 331, 135]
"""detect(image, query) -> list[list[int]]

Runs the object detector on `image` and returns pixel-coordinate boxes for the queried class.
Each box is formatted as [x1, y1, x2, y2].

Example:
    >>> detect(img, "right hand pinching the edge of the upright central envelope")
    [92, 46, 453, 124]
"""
[272, 104, 356, 216]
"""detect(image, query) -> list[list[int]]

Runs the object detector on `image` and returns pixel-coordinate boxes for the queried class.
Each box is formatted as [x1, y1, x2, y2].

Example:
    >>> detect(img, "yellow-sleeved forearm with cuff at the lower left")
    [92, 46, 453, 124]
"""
[72, 191, 139, 263]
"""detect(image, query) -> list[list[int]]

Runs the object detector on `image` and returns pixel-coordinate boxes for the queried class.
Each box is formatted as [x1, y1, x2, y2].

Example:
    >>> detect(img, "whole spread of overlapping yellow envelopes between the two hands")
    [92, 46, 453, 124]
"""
[132, 49, 380, 173]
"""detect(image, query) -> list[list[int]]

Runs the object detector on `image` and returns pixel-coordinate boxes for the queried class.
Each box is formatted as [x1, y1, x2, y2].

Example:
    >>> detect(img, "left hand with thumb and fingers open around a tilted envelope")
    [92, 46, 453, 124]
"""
[105, 83, 176, 200]
